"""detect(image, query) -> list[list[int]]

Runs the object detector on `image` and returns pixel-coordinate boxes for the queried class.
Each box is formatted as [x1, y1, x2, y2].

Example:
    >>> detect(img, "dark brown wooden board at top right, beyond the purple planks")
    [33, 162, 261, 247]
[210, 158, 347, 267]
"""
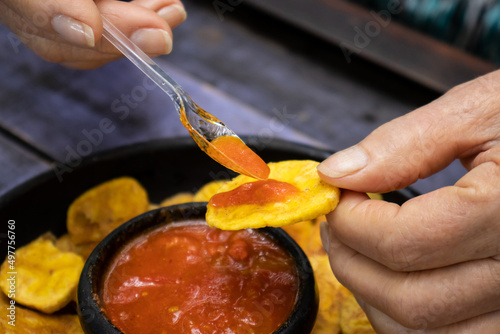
[245, 0, 498, 92]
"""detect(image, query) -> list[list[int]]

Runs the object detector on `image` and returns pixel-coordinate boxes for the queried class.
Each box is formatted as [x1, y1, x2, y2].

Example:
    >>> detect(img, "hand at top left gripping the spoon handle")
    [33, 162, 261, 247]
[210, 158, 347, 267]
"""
[0, 0, 186, 69]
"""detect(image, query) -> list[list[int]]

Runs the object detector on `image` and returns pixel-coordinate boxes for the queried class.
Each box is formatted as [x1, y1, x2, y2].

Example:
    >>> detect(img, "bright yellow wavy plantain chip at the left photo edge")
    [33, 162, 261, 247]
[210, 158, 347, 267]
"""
[0, 236, 84, 313]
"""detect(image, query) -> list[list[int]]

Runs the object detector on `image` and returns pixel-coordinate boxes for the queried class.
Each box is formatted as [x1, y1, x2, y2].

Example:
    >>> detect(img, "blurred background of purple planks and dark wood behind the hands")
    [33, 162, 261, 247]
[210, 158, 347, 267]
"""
[0, 0, 500, 201]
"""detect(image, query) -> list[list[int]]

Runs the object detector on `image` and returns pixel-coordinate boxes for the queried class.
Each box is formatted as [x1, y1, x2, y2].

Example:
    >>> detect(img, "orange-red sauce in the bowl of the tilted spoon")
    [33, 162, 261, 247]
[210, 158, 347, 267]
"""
[209, 136, 270, 180]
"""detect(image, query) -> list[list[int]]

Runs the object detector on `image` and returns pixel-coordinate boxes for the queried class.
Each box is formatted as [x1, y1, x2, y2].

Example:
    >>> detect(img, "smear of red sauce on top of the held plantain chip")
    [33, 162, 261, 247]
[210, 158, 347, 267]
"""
[209, 179, 300, 208]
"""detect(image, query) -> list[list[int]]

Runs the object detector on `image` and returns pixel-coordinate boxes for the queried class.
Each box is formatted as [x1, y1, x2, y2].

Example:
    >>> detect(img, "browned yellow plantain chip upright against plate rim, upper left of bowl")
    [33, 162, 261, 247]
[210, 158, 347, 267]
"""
[66, 177, 149, 244]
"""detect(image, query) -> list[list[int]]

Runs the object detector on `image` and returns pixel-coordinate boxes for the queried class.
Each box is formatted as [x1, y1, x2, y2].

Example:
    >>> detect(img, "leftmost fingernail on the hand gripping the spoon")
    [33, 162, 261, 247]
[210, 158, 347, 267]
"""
[51, 15, 95, 47]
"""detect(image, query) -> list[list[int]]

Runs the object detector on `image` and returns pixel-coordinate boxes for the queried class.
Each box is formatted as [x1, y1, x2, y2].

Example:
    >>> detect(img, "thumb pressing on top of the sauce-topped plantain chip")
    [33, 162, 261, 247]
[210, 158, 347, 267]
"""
[318, 86, 473, 192]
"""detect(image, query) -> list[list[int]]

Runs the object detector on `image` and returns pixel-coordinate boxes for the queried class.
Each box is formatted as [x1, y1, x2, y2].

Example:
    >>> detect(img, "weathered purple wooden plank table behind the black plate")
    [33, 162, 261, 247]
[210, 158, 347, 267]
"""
[0, 0, 486, 201]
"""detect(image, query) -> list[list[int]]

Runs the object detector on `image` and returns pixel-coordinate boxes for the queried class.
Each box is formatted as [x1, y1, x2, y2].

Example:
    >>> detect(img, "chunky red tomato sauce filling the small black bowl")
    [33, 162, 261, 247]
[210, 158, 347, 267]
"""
[102, 221, 299, 334]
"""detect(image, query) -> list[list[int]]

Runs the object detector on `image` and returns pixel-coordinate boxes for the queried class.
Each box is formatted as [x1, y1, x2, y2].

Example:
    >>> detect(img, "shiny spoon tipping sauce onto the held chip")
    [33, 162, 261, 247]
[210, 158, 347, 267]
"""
[101, 16, 269, 179]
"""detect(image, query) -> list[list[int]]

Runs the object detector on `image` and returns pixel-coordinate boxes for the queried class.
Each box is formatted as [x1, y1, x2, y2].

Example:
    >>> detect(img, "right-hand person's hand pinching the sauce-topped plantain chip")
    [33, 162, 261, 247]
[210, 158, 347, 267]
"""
[318, 71, 500, 334]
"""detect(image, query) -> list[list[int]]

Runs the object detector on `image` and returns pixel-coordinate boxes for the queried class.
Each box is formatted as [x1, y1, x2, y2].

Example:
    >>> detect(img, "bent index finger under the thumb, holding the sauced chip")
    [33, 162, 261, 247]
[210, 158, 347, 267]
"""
[327, 159, 500, 271]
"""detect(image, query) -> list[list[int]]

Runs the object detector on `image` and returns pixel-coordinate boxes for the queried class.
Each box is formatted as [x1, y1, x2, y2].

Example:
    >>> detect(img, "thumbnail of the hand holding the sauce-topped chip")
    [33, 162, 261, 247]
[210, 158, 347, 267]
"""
[318, 146, 368, 178]
